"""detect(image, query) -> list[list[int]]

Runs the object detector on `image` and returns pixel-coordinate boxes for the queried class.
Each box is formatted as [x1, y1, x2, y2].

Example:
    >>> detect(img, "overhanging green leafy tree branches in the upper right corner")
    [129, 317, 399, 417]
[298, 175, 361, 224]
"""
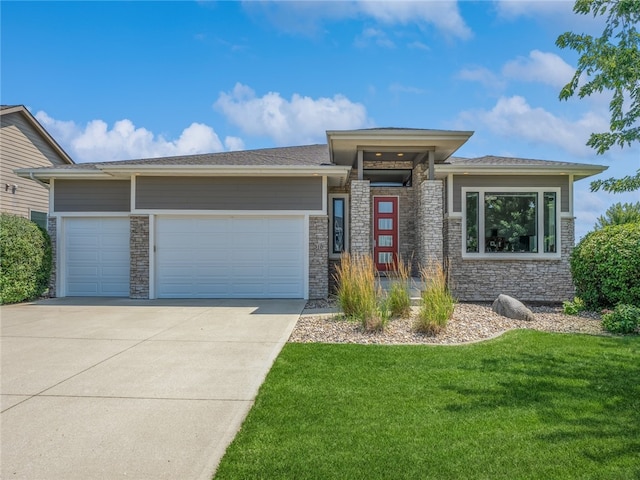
[556, 0, 640, 192]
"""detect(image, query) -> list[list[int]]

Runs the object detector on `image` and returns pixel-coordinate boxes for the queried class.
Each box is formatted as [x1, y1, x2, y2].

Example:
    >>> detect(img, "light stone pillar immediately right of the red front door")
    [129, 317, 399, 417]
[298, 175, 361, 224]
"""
[416, 180, 444, 266]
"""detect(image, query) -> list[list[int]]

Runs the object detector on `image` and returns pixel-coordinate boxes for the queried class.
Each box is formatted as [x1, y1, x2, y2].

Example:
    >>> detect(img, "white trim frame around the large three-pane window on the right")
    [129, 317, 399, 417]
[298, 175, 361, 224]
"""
[460, 186, 562, 260]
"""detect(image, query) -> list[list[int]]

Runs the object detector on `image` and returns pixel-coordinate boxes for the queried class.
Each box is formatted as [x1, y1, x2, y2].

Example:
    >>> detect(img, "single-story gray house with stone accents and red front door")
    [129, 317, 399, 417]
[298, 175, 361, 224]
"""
[19, 128, 606, 301]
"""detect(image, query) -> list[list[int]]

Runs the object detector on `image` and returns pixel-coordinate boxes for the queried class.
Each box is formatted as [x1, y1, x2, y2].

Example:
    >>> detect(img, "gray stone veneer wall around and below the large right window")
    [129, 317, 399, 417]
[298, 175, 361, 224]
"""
[446, 218, 575, 302]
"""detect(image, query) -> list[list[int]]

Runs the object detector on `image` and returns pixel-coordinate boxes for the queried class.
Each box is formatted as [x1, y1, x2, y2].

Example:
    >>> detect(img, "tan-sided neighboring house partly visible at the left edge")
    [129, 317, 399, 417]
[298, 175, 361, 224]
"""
[0, 105, 73, 228]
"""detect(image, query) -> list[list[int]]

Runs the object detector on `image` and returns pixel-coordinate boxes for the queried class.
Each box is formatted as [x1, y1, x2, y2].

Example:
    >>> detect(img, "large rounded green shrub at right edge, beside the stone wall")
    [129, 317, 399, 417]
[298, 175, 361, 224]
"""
[571, 223, 640, 310]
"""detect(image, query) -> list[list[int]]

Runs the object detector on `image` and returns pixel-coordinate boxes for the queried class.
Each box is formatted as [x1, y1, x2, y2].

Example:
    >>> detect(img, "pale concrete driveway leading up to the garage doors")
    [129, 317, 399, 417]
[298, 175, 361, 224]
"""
[0, 299, 304, 480]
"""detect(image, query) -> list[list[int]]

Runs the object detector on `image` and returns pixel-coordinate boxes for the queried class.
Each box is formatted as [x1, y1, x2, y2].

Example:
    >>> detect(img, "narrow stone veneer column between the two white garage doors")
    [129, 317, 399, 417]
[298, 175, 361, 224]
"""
[129, 215, 149, 299]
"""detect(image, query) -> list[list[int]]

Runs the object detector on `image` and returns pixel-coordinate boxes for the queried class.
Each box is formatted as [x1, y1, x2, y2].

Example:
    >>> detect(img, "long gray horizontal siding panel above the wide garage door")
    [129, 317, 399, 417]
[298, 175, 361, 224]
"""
[136, 177, 322, 210]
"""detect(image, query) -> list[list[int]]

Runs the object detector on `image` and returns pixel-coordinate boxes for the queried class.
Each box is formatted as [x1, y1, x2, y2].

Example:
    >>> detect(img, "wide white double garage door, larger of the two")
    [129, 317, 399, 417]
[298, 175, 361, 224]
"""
[156, 217, 305, 298]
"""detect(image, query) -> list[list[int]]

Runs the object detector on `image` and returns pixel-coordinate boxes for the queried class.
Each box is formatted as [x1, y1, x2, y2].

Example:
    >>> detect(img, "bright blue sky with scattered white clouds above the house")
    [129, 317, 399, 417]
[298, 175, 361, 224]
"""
[0, 0, 640, 238]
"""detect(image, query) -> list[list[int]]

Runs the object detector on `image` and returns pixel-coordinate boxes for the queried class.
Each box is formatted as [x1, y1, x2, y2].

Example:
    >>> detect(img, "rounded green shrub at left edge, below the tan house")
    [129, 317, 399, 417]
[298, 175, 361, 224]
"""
[0, 213, 51, 304]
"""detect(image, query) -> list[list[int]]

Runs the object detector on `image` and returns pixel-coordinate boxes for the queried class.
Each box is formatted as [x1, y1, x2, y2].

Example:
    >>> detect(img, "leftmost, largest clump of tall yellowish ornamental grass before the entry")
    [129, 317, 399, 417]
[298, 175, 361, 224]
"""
[335, 253, 377, 321]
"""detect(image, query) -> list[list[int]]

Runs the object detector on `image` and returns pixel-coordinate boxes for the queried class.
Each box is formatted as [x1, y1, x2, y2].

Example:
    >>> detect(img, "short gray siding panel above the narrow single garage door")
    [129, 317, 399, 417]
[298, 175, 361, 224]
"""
[53, 180, 131, 212]
